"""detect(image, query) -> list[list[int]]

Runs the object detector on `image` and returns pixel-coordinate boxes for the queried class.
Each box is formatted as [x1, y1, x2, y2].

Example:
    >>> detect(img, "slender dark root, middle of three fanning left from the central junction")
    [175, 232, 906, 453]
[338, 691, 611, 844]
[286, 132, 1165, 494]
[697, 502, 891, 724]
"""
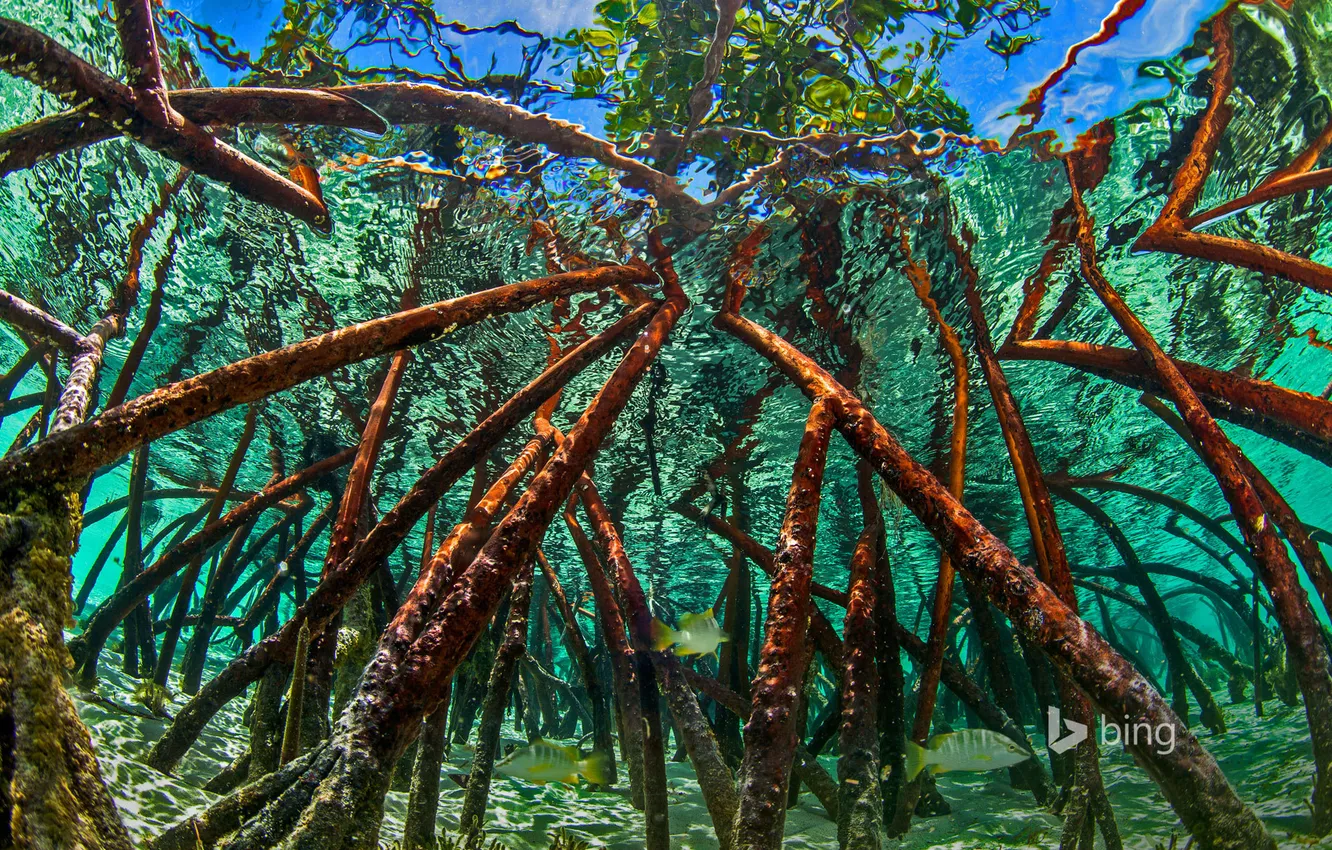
[149, 304, 655, 771]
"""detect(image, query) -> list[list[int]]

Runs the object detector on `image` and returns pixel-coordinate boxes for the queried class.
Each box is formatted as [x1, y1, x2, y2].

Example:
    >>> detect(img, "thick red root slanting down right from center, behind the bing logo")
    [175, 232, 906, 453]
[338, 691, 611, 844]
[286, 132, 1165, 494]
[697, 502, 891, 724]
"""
[717, 238, 1276, 850]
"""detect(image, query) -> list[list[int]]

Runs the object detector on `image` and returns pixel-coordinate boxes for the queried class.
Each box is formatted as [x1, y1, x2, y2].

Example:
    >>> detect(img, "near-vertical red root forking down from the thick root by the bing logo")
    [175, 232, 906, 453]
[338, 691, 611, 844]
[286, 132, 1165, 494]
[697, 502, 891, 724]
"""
[735, 397, 835, 850]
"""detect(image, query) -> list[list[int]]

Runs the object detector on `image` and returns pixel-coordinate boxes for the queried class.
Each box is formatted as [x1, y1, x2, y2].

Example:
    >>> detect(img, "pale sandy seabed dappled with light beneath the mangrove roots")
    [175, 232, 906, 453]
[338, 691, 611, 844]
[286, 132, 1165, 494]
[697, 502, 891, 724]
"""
[73, 651, 1332, 850]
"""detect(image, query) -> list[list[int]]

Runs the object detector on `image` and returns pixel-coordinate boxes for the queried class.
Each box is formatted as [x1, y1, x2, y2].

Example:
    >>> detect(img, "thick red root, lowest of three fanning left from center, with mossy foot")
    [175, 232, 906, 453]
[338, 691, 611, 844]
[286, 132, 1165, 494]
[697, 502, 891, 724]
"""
[158, 261, 687, 850]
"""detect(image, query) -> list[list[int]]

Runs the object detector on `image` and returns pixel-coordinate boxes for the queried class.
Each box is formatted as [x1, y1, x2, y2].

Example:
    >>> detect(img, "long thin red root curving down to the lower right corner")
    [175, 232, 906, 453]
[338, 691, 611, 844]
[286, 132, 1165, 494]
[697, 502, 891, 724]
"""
[1068, 149, 1332, 834]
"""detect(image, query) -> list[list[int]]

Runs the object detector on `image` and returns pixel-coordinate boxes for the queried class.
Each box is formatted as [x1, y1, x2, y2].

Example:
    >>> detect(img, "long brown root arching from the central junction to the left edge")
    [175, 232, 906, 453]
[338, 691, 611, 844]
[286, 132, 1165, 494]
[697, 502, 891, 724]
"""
[0, 266, 649, 486]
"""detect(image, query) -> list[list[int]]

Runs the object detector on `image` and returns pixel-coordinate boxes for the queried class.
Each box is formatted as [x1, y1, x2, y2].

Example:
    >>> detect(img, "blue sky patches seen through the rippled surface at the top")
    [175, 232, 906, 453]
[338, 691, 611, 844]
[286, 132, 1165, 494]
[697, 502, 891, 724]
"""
[168, 0, 1224, 143]
